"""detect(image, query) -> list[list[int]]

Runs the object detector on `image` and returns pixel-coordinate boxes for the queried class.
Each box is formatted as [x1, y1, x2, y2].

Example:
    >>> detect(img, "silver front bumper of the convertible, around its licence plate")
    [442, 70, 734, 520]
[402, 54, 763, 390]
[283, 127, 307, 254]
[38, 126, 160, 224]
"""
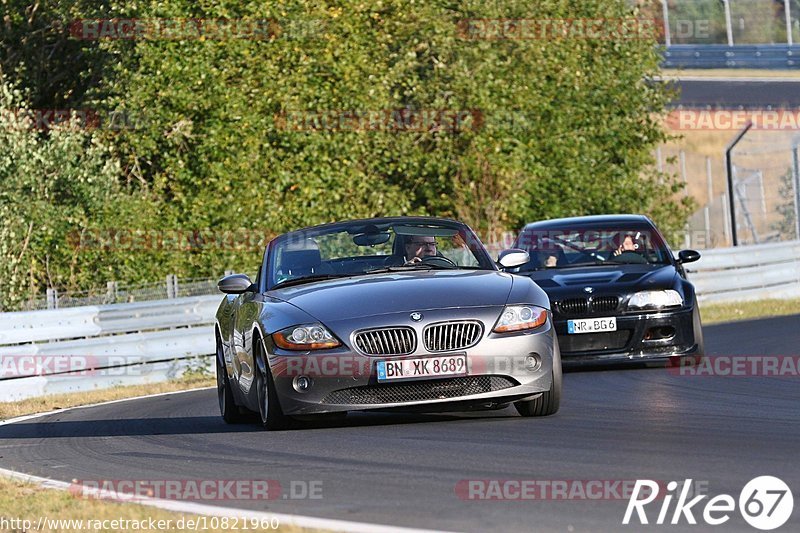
[262, 321, 554, 415]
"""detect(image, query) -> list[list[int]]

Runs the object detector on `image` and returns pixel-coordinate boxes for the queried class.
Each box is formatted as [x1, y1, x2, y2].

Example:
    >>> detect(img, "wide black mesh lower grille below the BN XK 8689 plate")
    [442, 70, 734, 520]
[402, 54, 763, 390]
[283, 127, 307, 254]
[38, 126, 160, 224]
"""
[322, 376, 519, 405]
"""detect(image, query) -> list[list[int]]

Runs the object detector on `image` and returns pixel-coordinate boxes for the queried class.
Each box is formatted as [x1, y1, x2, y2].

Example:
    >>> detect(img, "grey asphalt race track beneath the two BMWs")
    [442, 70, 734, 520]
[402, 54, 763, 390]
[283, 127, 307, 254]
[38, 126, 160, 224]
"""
[0, 316, 800, 531]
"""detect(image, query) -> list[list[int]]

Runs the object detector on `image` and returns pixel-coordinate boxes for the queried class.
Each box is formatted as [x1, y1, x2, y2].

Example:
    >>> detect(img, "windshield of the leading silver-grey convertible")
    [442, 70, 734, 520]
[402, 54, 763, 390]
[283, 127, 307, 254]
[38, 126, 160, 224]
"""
[267, 219, 496, 289]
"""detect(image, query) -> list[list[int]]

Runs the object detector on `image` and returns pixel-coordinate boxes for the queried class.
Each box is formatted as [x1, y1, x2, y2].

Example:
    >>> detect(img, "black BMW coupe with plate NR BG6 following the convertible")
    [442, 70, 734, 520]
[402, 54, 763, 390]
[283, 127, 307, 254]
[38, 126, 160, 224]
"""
[514, 215, 704, 367]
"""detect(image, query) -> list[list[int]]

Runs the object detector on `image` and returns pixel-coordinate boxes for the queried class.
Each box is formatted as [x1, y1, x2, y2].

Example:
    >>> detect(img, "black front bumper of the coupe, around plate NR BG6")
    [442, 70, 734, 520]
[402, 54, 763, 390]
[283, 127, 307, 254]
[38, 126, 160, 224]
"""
[555, 307, 703, 367]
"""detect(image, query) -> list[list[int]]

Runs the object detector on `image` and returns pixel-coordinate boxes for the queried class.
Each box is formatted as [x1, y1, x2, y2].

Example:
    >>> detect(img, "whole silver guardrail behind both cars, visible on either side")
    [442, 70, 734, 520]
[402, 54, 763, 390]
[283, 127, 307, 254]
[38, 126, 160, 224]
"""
[0, 241, 800, 401]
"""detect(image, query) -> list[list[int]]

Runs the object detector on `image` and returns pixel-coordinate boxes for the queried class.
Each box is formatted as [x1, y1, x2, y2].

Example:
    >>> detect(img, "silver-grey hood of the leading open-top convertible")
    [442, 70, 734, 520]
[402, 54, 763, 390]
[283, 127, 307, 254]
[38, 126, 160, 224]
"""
[269, 270, 513, 323]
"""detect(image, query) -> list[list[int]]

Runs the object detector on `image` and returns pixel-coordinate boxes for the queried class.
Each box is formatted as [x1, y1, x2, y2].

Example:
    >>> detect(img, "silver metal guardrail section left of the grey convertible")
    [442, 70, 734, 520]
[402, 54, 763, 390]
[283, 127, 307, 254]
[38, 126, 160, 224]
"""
[0, 294, 222, 401]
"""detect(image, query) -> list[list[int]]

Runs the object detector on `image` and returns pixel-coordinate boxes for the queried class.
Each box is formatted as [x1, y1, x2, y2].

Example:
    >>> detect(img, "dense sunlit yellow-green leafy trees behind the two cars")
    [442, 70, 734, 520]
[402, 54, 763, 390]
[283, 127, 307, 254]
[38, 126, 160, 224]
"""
[0, 0, 690, 304]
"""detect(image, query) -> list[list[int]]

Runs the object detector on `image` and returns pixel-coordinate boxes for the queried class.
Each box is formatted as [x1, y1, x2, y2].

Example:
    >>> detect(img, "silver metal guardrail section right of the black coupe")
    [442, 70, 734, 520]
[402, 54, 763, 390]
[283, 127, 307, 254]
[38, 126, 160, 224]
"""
[686, 241, 800, 302]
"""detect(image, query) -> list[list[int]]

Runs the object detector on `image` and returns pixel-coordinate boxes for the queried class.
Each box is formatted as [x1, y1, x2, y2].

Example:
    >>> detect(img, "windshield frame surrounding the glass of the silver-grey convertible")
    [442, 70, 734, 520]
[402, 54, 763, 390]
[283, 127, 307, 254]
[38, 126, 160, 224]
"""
[259, 217, 499, 292]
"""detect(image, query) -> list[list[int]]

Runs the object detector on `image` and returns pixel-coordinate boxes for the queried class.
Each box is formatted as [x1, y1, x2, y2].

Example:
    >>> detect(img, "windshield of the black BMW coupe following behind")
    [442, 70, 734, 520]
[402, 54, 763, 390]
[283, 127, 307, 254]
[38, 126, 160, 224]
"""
[515, 227, 671, 272]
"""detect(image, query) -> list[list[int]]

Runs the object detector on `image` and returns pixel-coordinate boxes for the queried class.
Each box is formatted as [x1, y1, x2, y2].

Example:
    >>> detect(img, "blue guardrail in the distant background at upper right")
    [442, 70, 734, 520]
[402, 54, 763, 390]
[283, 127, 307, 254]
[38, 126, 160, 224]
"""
[661, 44, 800, 69]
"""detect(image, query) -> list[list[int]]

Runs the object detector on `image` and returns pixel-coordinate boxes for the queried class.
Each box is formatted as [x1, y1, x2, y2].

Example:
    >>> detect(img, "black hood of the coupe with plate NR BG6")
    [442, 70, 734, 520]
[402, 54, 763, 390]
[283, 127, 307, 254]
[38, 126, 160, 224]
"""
[525, 265, 677, 299]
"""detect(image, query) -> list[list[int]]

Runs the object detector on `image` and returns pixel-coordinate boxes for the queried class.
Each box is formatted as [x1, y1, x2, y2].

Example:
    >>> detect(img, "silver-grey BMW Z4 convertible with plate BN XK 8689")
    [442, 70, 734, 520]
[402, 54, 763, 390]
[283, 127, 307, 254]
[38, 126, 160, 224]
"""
[215, 217, 562, 429]
